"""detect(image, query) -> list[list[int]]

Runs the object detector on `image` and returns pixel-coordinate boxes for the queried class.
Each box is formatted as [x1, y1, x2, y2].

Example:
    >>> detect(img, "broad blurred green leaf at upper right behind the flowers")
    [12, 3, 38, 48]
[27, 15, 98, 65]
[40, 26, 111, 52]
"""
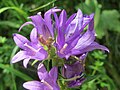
[95, 10, 120, 39]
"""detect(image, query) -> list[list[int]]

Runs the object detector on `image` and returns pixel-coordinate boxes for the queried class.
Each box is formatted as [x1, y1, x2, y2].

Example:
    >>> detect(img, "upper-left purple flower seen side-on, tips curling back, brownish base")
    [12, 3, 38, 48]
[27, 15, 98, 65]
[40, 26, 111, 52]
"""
[19, 7, 60, 45]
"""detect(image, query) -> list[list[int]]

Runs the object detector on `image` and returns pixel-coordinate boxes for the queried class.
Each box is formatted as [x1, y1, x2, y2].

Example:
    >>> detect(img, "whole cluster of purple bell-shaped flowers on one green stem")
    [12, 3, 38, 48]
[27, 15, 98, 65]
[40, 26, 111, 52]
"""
[11, 7, 109, 90]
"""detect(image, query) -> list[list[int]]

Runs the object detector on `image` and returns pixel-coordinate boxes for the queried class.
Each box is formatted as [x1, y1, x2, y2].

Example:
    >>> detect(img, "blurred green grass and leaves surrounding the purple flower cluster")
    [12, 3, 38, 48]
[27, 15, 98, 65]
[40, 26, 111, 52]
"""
[0, 0, 120, 90]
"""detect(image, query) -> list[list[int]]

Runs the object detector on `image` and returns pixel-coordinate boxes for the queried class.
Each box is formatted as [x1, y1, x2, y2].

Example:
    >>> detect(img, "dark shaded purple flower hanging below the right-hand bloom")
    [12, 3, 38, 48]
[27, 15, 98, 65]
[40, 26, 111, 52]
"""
[62, 61, 85, 87]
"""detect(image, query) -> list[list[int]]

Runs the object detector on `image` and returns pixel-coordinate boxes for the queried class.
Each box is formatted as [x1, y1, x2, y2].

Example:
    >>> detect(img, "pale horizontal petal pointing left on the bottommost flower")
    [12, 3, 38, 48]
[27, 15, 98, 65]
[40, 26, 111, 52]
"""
[23, 81, 43, 90]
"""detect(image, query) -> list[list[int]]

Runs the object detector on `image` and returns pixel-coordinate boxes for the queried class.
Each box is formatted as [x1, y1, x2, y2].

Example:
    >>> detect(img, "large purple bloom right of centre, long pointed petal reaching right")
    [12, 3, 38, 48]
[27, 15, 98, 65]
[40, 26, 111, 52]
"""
[54, 10, 109, 59]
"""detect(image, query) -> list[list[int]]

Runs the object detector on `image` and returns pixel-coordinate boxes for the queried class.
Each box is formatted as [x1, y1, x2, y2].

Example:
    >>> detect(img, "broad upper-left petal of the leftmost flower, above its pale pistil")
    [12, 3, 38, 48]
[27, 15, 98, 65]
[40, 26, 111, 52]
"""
[13, 34, 30, 49]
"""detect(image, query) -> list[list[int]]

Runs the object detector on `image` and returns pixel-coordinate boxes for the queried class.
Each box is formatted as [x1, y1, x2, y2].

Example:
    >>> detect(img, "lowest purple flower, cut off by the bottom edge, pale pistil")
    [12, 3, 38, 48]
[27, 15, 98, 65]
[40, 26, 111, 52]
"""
[23, 64, 60, 90]
